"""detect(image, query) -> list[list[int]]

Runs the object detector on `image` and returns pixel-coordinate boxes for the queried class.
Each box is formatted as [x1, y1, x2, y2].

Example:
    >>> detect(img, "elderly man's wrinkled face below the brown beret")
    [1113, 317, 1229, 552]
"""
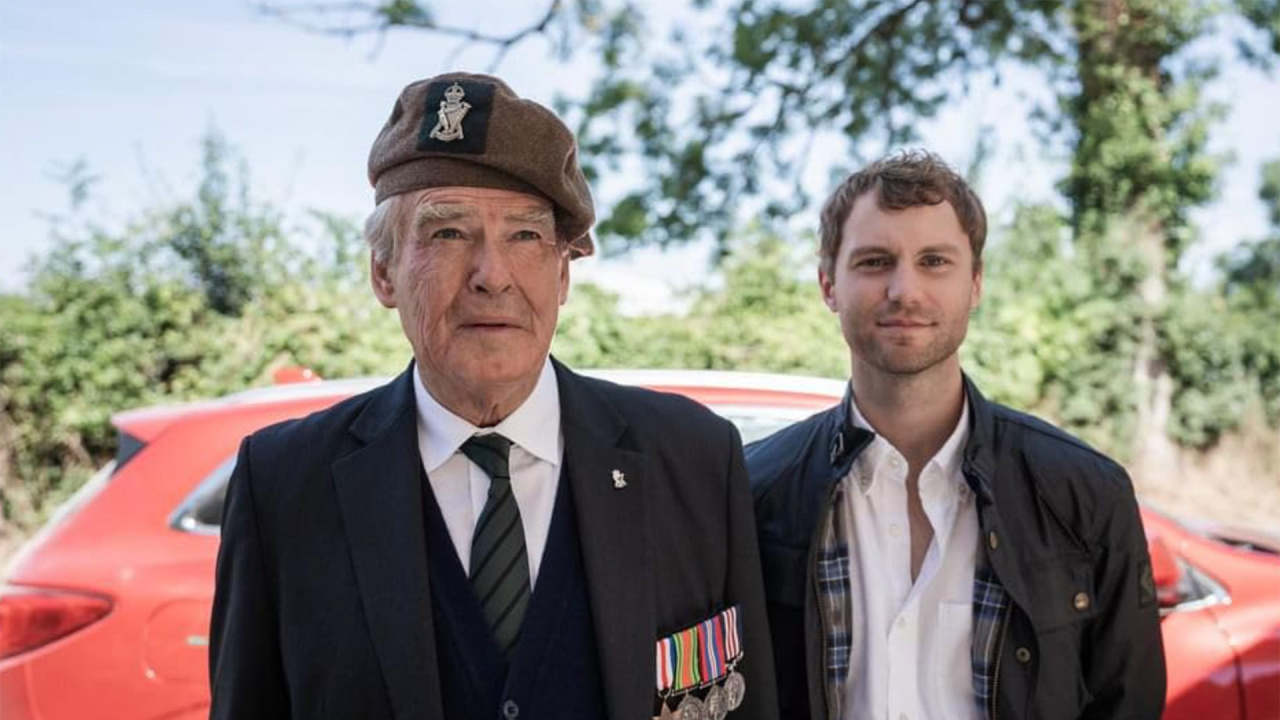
[372, 187, 568, 397]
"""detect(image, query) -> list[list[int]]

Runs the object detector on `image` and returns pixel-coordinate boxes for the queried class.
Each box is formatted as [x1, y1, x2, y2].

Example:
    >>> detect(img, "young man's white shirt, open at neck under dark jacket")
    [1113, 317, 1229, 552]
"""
[840, 392, 980, 720]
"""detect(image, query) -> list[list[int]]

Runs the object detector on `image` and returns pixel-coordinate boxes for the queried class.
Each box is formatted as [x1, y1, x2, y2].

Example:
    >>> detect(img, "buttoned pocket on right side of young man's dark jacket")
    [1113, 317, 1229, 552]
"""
[1006, 555, 1098, 719]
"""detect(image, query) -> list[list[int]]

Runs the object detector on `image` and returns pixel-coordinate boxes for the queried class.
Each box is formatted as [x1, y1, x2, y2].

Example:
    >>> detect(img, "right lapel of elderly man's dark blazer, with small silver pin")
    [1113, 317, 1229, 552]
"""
[556, 363, 657, 720]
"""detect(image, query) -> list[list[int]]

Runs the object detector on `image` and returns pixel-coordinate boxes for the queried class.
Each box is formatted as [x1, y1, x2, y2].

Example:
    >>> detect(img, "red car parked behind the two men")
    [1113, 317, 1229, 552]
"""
[0, 372, 1280, 720]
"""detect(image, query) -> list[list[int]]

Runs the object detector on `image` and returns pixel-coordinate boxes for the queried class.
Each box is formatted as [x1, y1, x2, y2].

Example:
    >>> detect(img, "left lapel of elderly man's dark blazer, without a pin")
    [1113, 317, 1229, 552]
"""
[333, 365, 442, 720]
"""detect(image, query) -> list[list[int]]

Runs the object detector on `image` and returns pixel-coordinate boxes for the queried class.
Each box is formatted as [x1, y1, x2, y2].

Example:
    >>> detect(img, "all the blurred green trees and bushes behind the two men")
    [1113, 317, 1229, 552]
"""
[0, 0, 1280, 545]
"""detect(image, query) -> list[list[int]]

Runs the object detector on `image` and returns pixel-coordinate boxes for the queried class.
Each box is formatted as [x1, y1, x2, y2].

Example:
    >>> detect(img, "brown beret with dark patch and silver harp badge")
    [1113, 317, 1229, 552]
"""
[369, 73, 595, 258]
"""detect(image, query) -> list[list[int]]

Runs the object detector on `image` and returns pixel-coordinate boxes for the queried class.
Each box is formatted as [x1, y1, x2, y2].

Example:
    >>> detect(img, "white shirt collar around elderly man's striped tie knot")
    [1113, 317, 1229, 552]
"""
[413, 357, 563, 474]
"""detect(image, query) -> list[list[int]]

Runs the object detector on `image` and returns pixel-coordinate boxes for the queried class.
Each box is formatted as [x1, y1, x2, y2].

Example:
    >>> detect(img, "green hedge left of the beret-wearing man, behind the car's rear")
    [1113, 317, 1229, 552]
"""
[0, 137, 408, 529]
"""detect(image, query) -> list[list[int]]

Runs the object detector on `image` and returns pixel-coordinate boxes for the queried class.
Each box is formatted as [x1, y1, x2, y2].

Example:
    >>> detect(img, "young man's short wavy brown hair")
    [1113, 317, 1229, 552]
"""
[818, 150, 987, 275]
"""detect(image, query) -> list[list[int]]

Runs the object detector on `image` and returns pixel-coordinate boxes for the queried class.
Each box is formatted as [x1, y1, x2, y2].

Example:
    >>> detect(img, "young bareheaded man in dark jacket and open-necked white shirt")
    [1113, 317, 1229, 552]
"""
[748, 152, 1165, 720]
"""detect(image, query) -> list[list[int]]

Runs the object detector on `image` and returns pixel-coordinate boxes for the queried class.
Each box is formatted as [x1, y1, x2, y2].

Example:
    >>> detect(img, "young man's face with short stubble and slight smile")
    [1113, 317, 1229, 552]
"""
[818, 193, 982, 375]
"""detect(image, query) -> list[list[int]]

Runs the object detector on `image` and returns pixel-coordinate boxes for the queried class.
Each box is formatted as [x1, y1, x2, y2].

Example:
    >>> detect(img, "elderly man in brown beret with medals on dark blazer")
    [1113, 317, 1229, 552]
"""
[210, 73, 777, 720]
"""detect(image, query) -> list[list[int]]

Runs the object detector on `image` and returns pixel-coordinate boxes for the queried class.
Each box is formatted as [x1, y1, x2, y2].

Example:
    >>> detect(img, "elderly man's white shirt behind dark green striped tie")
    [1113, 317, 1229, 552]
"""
[413, 359, 564, 588]
